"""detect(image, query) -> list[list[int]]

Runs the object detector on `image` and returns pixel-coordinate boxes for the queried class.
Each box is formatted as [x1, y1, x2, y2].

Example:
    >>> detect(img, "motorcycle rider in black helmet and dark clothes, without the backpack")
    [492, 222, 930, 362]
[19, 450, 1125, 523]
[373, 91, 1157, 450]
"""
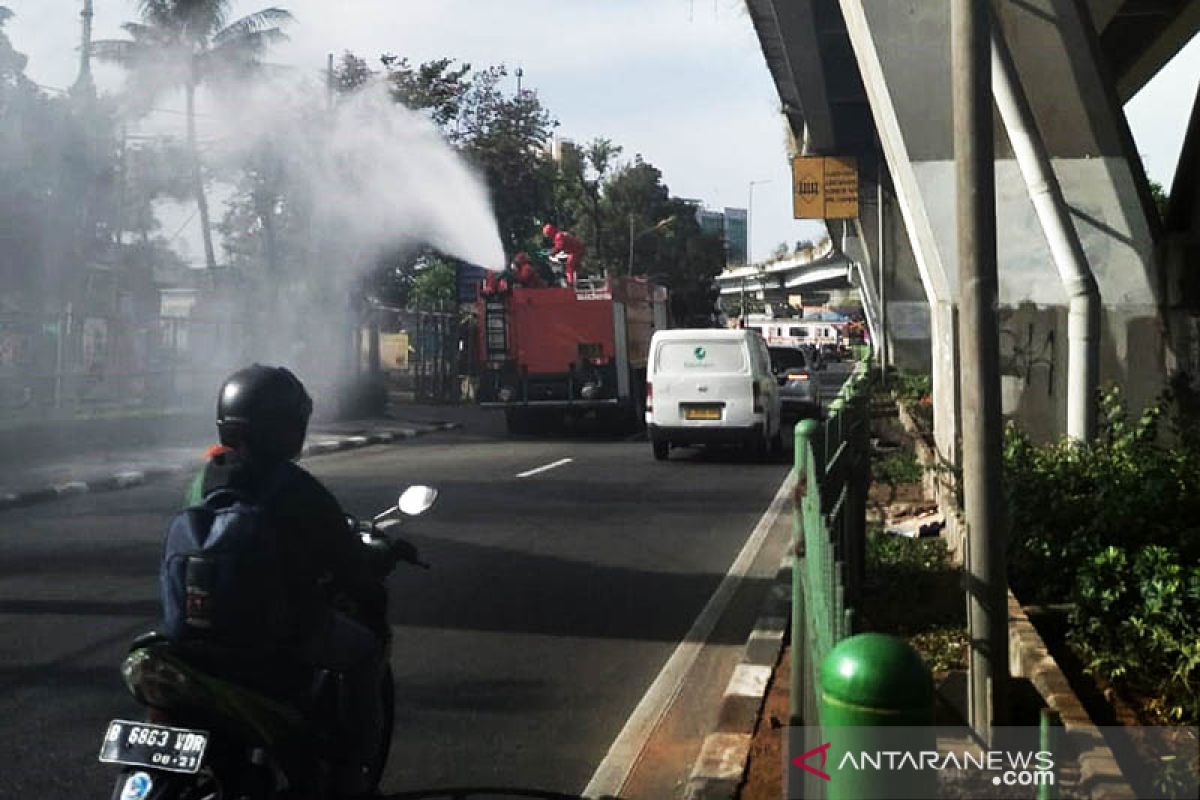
[187, 363, 402, 796]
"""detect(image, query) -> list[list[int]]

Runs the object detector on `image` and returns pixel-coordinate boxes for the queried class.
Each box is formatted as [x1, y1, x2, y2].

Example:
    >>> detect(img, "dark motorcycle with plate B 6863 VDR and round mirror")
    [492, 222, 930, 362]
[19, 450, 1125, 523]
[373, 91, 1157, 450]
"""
[100, 486, 438, 800]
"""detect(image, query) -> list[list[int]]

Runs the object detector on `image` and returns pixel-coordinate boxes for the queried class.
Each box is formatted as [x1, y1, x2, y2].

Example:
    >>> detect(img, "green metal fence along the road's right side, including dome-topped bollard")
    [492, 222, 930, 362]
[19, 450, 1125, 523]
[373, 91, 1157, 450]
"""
[785, 347, 936, 800]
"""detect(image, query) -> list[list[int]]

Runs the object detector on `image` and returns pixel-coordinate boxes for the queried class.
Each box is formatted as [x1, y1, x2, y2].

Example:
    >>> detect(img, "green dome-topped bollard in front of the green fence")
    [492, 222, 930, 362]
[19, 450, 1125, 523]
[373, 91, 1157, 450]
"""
[817, 633, 937, 800]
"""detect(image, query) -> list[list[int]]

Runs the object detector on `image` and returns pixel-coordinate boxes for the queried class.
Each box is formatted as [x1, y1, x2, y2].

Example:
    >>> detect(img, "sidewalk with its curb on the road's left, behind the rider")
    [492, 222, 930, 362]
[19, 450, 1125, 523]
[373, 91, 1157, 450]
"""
[0, 404, 467, 510]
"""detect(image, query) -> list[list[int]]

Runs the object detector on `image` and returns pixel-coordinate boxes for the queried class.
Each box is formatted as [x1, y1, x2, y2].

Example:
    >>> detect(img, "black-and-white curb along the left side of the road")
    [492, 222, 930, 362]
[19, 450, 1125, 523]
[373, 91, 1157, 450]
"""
[0, 422, 462, 511]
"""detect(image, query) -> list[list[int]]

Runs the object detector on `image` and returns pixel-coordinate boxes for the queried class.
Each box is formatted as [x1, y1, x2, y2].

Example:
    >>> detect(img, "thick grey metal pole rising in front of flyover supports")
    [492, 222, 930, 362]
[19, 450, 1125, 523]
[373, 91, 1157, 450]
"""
[950, 0, 1008, 742]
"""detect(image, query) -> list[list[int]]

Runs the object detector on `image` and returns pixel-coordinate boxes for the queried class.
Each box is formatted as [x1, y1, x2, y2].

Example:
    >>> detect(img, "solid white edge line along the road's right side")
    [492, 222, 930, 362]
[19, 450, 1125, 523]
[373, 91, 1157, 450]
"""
[583, 470, 796, 798]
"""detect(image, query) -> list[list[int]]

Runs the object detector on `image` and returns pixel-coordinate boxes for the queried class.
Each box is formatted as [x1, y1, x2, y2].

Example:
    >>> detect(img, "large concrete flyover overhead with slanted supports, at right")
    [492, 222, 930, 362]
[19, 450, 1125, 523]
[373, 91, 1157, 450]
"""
[746, 0, 1200, 450]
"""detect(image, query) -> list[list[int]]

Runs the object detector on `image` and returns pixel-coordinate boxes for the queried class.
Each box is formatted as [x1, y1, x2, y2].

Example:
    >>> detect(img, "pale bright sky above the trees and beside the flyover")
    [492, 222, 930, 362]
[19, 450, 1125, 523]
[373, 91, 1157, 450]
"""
[2, 0, 1200, 268]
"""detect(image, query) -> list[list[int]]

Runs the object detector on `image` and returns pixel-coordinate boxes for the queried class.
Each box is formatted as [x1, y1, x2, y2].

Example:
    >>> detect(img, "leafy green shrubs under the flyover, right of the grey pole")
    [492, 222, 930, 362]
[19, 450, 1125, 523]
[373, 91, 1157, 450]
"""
[1004, 389, 1200, 723]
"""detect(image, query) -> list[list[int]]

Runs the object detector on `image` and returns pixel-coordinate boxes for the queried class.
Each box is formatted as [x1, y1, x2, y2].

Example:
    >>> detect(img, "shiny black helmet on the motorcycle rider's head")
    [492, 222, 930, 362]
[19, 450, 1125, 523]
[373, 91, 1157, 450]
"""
[217, 363, 312, 461]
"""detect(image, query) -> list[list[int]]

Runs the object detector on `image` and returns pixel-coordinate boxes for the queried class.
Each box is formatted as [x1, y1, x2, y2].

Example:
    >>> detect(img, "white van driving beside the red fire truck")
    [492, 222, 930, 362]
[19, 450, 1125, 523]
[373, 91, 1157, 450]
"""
[646, 329, 780, 461]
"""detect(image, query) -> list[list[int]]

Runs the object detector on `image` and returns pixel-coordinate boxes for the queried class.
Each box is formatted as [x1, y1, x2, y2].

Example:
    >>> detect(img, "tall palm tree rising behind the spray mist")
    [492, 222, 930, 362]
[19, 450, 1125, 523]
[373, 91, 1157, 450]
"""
[92, 0, 292, 270]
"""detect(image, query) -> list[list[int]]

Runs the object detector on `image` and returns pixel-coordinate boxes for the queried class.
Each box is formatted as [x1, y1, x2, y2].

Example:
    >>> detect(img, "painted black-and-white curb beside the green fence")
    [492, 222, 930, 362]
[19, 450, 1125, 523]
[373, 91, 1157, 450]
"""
[684, 554, 793, 800]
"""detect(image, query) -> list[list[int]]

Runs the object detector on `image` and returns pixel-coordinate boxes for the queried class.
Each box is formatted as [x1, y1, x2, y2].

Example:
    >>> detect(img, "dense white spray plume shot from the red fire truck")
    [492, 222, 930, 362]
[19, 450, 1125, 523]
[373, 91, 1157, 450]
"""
[190, 73, 505, 412]
